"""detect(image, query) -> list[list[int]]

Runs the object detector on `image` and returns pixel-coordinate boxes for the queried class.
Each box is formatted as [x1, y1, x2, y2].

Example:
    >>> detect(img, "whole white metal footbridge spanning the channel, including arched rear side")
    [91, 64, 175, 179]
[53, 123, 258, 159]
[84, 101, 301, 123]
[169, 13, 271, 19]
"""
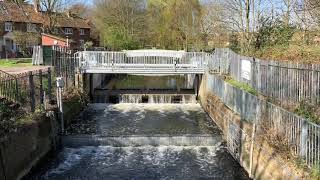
[75, 50, 211, 74]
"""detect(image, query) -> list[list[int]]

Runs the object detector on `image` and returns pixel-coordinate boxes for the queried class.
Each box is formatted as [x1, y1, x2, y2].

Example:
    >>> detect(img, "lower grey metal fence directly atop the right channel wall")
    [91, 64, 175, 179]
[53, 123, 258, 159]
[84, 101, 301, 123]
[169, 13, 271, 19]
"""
[206, 74, 320, 167]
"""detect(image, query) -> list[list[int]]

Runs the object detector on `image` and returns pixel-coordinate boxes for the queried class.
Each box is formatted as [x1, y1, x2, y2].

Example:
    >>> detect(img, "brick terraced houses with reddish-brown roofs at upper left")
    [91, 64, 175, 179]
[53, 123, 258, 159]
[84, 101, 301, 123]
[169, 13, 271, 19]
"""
[0, 0, 90, 58]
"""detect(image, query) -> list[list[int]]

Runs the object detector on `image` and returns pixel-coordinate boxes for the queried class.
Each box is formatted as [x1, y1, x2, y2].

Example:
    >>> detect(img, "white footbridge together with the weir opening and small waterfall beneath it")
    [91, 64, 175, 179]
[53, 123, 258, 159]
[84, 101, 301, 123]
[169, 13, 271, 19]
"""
[75, 50, 210, 103]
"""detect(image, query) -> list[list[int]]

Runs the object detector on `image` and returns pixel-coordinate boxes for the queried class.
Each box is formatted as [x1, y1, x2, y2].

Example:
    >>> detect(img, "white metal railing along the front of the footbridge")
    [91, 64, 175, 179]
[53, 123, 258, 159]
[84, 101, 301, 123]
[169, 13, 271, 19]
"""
[75, 51, 210, 72]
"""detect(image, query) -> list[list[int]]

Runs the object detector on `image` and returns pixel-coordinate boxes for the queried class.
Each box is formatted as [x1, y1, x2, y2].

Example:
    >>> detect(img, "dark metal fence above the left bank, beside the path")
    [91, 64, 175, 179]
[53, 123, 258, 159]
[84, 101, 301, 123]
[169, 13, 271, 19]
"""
[0, 68, 53, 112]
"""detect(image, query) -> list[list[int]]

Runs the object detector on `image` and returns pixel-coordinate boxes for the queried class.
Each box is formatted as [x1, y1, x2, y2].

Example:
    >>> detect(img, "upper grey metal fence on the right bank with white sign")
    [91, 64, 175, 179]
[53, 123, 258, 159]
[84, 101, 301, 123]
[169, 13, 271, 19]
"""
[209, 49, 320, 105]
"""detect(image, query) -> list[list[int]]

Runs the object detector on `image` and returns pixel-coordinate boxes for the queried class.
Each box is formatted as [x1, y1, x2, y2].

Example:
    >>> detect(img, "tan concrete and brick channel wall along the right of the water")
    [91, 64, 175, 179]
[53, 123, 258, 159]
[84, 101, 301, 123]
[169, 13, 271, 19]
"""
[200, 74, 305, 180]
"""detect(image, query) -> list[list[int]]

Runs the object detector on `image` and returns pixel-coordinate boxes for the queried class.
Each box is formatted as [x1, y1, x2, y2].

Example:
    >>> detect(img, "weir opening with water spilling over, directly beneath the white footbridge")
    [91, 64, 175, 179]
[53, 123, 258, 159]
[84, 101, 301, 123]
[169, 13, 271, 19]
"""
[90, 74, 196, 104]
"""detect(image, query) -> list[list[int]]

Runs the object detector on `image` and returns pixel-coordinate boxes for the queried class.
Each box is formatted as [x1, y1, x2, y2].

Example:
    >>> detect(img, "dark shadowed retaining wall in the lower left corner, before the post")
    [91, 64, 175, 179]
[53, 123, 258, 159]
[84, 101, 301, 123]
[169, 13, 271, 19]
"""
[0, 115, 53, 180]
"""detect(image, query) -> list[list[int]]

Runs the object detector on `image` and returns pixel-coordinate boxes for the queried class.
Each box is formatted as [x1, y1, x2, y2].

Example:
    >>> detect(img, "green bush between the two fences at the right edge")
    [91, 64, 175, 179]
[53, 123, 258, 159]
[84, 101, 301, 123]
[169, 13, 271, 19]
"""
[294, 101, 320, 124]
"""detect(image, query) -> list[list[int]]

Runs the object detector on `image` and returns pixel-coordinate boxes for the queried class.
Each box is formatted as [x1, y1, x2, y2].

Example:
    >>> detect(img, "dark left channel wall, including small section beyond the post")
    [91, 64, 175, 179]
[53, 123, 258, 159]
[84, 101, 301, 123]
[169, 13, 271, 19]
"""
[0, 102, 83, 180]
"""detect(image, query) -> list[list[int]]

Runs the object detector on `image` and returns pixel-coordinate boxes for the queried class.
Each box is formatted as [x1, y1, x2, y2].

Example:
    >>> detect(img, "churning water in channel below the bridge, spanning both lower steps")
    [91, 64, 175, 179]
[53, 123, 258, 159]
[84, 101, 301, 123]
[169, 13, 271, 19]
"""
[27, 104, 248, 180]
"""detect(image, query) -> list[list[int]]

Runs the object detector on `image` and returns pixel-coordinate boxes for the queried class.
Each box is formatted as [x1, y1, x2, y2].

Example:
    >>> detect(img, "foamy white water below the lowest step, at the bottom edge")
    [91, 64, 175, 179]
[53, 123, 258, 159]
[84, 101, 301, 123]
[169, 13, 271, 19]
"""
[41, 145, 246, 180]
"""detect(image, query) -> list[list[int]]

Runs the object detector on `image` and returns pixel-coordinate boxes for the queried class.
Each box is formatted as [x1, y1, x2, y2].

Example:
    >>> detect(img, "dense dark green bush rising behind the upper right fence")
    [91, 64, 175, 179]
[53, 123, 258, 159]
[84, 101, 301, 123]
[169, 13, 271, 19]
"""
[255, 18, 296, 49]
